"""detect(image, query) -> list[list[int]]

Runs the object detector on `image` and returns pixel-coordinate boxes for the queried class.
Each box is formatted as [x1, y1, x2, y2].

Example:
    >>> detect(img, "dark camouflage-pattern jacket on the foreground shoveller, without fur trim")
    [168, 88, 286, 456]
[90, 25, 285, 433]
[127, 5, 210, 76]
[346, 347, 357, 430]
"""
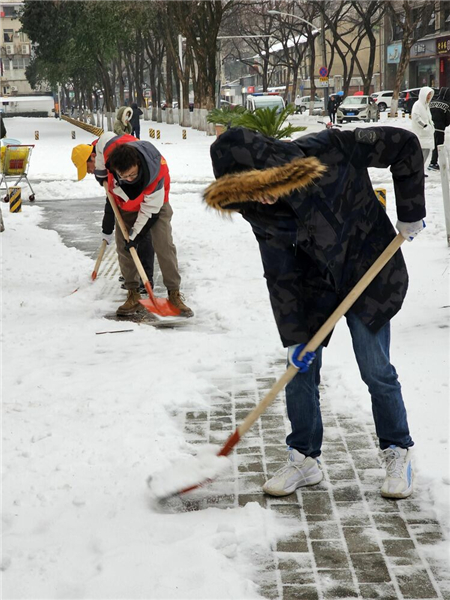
[211, 127, 425, 346]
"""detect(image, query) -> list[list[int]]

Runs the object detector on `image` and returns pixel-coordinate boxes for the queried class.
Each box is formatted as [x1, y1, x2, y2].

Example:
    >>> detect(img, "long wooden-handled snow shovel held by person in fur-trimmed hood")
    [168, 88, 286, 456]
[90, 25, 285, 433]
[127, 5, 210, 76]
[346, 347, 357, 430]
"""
[149, 233, 405, 500]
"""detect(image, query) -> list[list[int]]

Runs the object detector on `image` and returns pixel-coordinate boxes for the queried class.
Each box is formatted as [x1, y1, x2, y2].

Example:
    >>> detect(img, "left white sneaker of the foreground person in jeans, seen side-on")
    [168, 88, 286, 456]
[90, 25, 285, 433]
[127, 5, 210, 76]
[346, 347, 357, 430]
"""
[263, 448, 323, 496]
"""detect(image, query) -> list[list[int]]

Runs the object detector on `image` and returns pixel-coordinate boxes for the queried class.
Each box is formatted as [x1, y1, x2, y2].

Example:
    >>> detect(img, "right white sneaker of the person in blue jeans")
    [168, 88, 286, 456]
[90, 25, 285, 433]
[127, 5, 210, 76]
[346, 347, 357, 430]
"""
[381, 446, 413, 498]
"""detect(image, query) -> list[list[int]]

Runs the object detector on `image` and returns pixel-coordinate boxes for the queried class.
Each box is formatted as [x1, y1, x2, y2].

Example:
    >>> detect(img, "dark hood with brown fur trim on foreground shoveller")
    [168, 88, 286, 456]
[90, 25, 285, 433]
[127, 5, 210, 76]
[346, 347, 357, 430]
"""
[203, 127, 326, 211]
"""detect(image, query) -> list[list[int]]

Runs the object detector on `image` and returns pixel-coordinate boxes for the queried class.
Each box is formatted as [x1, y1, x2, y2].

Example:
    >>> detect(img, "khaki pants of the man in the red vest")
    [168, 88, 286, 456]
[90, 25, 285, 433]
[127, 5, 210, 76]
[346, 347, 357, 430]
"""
[116, 202, 181, 292]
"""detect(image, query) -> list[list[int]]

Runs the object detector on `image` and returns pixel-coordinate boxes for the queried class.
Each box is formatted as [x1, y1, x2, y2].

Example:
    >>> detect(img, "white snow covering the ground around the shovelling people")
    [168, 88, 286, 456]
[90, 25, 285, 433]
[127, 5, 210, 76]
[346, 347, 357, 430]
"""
[0, 114, 450, 600]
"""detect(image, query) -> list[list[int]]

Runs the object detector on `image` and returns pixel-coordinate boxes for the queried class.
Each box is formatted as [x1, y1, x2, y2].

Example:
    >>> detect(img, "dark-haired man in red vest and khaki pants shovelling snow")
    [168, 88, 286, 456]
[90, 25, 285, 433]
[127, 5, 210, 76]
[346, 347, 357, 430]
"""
[94, 133, 194, 317]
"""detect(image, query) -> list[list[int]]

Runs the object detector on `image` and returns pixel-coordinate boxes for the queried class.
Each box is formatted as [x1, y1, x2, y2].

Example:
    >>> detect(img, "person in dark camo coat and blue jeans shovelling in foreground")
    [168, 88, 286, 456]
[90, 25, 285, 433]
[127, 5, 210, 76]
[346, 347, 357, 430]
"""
[205, 127, 425, 498]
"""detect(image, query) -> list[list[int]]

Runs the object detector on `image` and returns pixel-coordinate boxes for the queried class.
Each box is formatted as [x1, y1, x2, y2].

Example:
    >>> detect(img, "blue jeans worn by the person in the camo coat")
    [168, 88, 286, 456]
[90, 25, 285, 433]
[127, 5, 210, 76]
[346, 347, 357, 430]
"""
[286, 312, 414, 458]
